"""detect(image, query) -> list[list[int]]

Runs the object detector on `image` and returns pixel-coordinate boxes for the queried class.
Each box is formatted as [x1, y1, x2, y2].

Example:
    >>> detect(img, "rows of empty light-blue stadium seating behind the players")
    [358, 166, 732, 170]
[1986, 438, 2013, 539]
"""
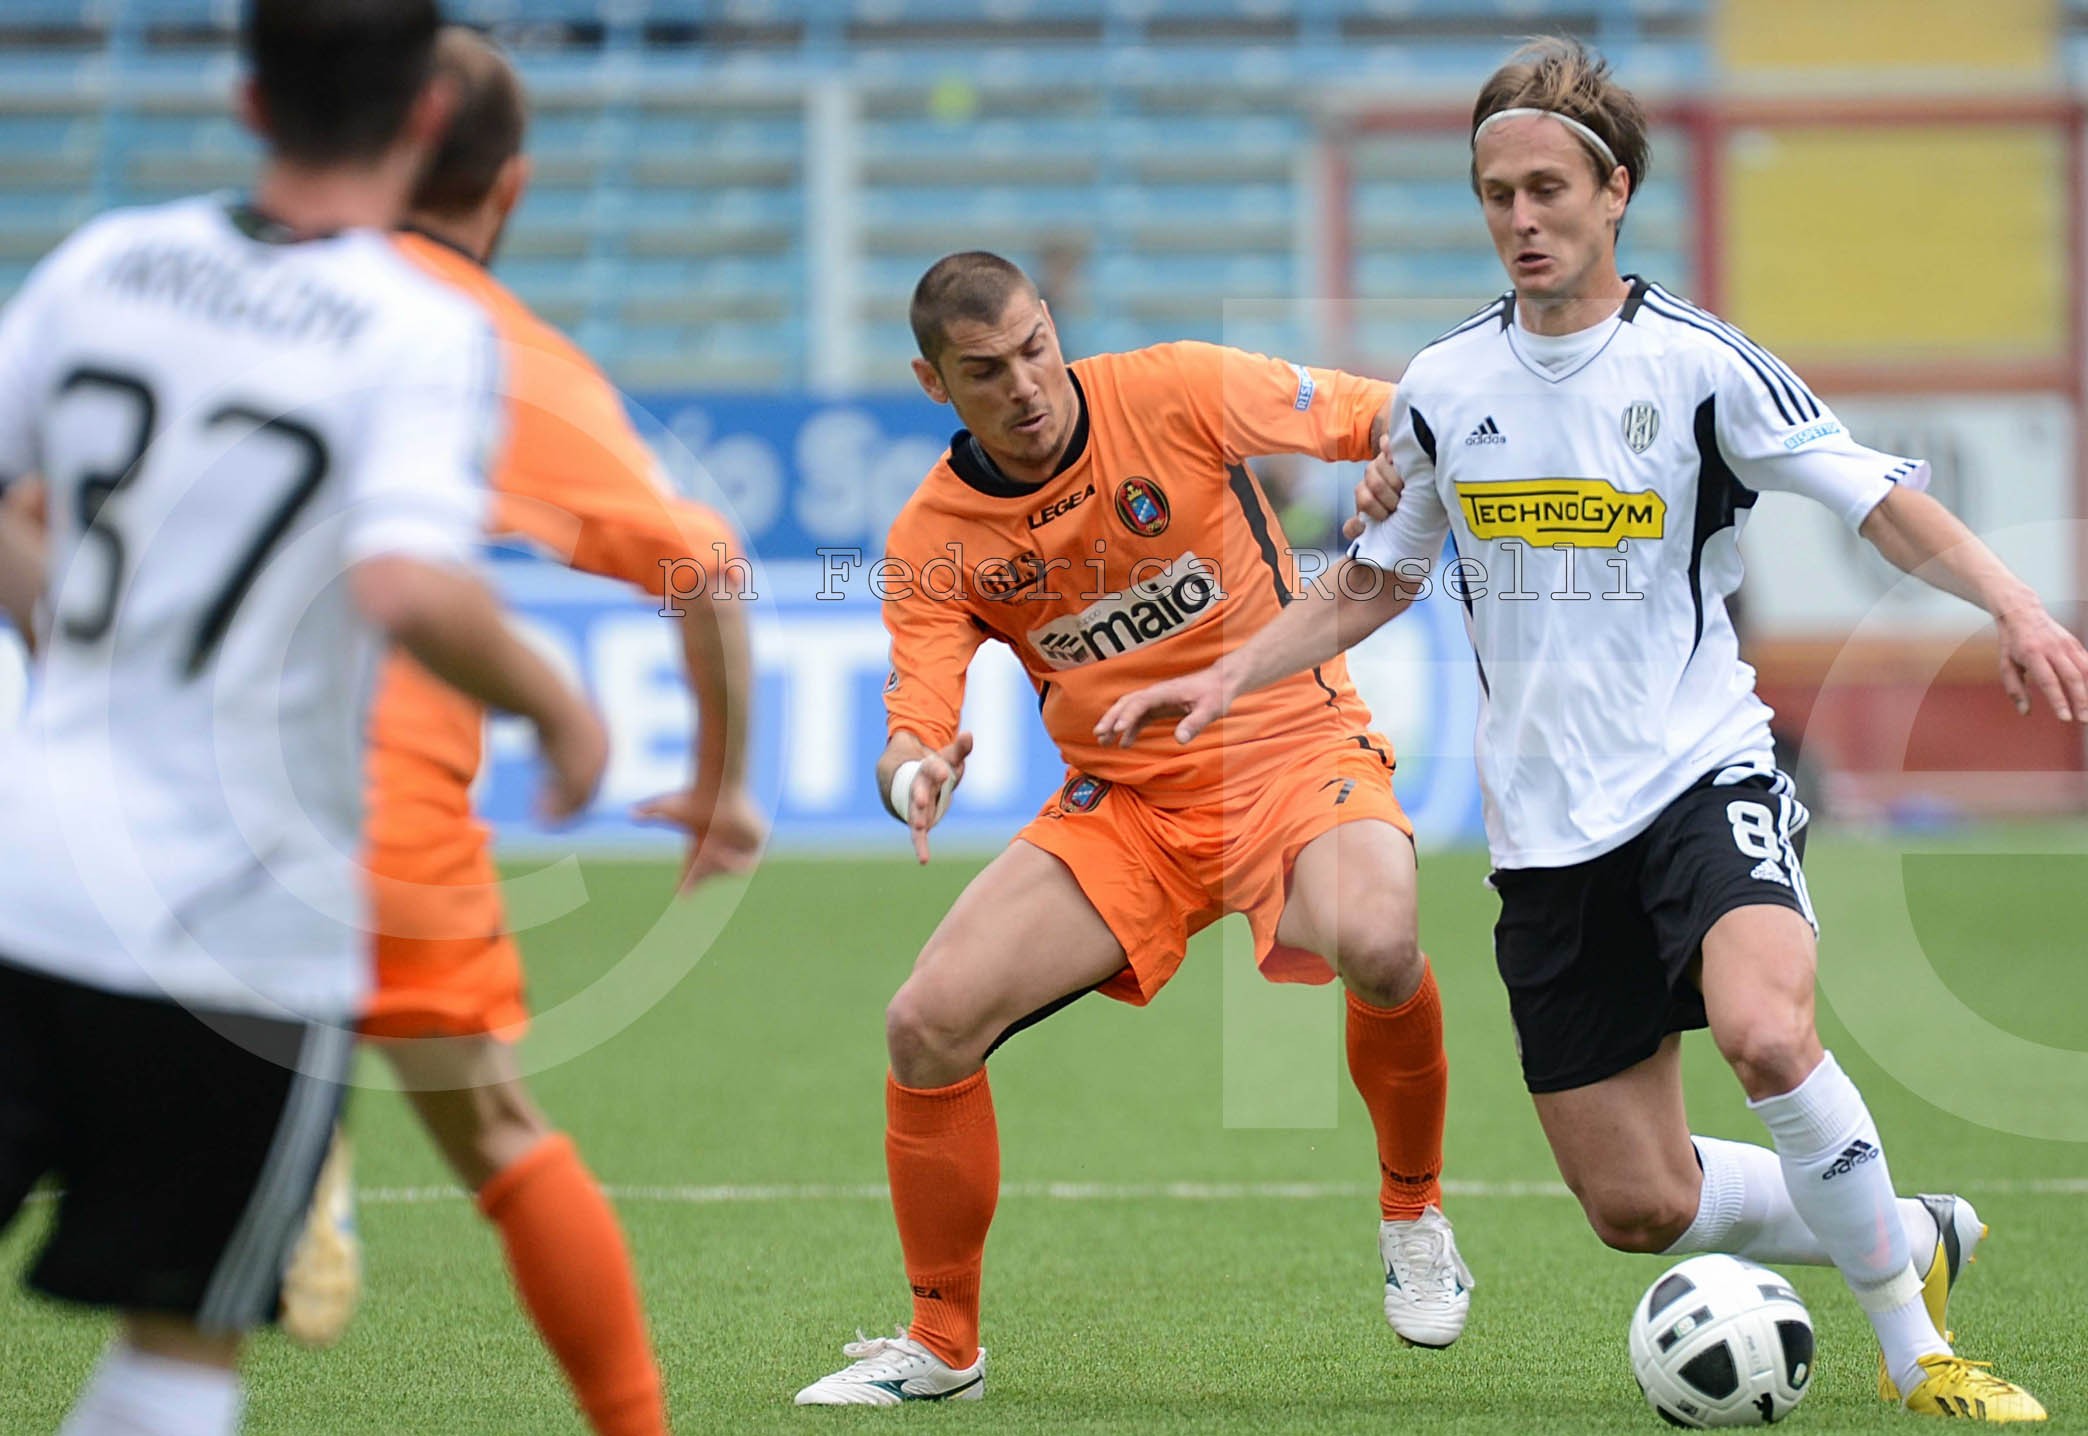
[0, 0, 1712, 390]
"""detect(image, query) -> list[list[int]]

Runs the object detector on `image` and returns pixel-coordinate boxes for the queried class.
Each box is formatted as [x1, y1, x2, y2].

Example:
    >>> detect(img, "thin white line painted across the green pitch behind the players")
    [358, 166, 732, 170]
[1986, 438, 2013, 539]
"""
[346, 1177, 2088, 1206]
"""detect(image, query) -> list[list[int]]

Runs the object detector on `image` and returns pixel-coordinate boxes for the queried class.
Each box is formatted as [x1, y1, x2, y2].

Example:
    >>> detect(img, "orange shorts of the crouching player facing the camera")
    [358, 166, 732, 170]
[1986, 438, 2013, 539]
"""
[1017, 733, 1414, 1006]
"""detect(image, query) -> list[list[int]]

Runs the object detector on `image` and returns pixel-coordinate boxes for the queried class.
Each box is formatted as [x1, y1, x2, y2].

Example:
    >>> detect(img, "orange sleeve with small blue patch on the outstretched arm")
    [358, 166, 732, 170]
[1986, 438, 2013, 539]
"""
[1169, 342, 1393, 463]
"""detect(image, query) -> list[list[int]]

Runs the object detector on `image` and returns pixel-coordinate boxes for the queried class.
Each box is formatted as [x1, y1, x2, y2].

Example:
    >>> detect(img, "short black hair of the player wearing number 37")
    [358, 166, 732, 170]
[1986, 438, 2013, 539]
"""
[240, 0, 441, 165]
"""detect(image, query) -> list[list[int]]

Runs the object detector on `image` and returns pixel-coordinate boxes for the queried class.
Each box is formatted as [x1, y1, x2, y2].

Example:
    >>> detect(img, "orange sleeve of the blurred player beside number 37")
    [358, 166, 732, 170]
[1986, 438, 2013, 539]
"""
[493, 340, 743, 597]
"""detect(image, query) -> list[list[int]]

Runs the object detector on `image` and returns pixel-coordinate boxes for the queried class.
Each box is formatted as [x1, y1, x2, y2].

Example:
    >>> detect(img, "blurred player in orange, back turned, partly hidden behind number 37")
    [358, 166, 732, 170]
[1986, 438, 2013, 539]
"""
[284, 27, 764, 1436]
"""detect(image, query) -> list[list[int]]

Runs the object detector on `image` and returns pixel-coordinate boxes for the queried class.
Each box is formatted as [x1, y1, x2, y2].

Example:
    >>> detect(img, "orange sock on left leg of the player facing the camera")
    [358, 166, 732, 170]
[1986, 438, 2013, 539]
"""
[885, 1067, 1000, 1369]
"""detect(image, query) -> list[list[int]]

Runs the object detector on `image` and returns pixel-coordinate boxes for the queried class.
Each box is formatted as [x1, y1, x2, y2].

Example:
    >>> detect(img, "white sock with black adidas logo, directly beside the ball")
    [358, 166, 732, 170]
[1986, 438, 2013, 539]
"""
[1748, 1052, 1950, 1392]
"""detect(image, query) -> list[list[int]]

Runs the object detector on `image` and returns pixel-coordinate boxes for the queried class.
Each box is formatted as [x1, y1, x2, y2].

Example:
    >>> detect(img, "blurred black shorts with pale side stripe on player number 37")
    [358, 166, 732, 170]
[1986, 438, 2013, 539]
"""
[0, 960, 353, 1332]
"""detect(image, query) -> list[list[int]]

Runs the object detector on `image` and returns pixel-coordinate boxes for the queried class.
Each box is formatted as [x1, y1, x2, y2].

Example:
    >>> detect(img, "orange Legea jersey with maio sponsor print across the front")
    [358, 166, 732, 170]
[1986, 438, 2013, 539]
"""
[881, 342, 1393, 804]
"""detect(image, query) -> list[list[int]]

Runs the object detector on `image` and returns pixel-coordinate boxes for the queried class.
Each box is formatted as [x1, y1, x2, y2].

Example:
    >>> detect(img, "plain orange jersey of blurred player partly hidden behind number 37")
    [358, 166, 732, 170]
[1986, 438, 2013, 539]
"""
[367, 234, 739, 851]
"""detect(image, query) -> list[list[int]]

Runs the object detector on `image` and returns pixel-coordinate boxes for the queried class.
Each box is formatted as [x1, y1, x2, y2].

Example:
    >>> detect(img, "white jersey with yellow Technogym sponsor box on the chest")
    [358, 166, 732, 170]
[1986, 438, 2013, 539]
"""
[1351, 280, 1927, 868]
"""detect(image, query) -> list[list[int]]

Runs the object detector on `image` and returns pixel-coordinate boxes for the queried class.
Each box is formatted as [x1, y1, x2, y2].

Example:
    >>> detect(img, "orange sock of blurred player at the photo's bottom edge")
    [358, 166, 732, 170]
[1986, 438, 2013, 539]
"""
[478, 1133, 666, 1436]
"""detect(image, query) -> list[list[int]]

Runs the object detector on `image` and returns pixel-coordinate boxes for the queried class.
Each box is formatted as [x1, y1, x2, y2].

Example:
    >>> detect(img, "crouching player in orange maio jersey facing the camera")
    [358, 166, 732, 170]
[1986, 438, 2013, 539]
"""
[798, 253, 1470, 1405]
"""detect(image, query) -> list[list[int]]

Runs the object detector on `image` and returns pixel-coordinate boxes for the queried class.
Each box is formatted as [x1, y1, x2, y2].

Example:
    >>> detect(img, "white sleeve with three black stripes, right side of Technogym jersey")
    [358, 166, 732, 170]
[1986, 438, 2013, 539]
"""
[1716, 344, 1929, 528]
